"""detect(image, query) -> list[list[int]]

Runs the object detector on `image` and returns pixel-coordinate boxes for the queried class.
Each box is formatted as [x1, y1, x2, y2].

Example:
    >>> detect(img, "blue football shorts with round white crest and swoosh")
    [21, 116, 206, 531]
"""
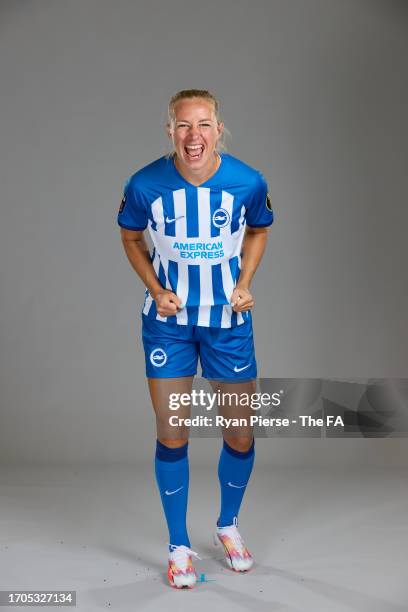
[142, 315, 257, 382]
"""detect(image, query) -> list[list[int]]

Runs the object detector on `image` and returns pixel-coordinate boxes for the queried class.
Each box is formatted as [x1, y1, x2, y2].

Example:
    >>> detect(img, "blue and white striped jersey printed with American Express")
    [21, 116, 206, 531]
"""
[118, 153, 273, 327]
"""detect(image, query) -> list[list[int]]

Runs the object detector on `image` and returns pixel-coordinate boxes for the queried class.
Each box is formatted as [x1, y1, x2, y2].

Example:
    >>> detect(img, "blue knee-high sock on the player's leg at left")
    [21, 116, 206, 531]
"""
[154, 440, 190, 548]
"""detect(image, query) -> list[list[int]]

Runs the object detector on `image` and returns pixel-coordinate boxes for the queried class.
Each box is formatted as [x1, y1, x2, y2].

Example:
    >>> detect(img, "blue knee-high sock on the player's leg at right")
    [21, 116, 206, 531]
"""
[217, 439, 255, 527]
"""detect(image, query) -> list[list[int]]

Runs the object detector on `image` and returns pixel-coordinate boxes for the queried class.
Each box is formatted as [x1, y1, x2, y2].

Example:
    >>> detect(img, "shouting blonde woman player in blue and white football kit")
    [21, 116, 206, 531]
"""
[118, 89, 273, 588]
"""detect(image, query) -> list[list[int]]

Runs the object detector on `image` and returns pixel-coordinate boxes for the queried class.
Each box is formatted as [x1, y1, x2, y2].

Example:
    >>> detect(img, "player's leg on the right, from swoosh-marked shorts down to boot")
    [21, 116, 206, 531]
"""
[200, 320, 257, 572]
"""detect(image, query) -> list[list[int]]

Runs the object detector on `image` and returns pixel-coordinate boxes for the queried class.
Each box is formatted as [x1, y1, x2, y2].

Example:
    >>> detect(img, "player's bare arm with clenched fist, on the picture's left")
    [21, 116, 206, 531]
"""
[120, 227, 181, 317]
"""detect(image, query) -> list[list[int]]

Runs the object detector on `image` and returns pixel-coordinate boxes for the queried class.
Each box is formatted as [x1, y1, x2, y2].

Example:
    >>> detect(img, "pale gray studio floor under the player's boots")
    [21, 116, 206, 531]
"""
[0, 464, 408, 612]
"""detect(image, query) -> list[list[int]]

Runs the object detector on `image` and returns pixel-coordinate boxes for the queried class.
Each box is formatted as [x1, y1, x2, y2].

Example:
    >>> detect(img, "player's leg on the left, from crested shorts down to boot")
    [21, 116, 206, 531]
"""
[142, 317, 198, 588]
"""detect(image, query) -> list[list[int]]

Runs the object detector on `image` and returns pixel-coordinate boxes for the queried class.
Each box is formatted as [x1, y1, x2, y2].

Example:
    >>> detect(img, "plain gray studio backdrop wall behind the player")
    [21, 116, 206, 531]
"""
[0, 0, 408, 465]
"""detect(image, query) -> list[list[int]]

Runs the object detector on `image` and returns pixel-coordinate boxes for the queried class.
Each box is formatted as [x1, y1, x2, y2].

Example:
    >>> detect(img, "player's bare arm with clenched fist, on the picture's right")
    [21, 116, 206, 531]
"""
[231, 226, 268, 312]
